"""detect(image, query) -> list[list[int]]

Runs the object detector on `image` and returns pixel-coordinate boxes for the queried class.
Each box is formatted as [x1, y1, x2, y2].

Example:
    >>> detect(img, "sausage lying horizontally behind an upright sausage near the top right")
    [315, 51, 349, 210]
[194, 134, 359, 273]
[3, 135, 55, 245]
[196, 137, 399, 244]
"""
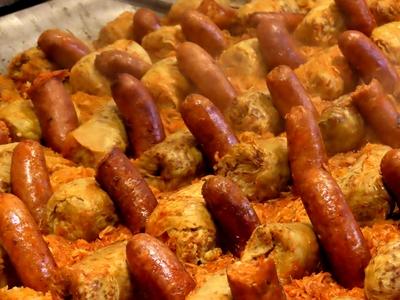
[247, 12, 305, 32]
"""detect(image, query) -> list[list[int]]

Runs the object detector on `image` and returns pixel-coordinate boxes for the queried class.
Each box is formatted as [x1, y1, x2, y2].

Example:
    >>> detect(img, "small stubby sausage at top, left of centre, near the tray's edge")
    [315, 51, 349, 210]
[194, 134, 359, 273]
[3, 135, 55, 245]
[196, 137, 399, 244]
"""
[133, 7, 161, 44]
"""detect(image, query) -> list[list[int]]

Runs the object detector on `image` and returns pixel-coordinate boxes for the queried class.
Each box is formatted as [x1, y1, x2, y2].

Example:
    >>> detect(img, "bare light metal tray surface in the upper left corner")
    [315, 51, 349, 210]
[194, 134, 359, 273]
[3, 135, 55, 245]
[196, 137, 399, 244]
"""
[0, 0, 173, 73]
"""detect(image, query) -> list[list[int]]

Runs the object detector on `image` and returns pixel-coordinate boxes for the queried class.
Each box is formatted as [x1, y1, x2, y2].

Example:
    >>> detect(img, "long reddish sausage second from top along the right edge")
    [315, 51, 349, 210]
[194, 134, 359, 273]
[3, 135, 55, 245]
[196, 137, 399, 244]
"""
[338, 30, 400, 94]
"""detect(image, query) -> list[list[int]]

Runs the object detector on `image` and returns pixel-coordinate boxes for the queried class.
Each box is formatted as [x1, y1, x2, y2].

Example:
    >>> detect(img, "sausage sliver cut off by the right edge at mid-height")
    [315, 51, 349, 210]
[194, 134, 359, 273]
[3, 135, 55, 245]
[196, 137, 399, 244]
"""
[381, 149, 400, 206]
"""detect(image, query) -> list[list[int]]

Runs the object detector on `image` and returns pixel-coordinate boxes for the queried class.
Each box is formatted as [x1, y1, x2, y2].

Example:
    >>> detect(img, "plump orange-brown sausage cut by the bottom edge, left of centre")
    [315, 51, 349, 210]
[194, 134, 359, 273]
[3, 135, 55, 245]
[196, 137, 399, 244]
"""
[126, 233, 196, 300]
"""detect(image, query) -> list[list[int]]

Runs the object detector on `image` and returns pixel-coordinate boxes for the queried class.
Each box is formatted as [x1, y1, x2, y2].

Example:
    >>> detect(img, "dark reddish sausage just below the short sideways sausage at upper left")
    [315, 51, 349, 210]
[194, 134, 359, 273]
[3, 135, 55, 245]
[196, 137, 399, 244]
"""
[111, 74, 165, 157]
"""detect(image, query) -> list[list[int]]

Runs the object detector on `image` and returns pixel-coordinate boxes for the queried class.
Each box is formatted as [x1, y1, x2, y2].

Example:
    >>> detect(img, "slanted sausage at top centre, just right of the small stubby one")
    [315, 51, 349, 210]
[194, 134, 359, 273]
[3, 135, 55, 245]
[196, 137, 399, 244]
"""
[181, 10, 227, 57]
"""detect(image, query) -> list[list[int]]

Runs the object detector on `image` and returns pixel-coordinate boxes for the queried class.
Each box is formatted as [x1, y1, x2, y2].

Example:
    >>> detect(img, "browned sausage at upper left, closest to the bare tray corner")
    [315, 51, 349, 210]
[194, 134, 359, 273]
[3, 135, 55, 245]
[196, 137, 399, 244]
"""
[38, 29, 90, 69]
